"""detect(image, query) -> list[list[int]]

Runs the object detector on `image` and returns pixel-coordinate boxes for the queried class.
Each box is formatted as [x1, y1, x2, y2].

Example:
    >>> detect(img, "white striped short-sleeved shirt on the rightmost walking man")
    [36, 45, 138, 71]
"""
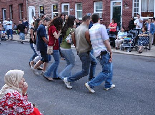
[89, 23, 109, 57]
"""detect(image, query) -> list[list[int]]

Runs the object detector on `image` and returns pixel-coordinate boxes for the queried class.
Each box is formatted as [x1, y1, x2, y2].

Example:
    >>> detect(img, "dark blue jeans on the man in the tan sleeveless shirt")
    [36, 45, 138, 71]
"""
[67, 52, 95, 82]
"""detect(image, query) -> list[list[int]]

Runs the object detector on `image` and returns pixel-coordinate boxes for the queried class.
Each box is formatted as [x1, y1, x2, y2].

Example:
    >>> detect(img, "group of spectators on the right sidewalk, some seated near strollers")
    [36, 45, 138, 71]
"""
[108, 14, 155, 53]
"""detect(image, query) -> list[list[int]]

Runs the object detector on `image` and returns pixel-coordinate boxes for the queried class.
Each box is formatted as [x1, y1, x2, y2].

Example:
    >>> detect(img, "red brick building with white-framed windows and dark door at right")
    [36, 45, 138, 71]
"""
[59, 0, 155, 28]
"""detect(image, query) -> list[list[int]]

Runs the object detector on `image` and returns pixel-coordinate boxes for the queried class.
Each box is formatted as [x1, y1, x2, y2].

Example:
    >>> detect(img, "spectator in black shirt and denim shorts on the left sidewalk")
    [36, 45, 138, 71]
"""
[17, 20, 25, 44]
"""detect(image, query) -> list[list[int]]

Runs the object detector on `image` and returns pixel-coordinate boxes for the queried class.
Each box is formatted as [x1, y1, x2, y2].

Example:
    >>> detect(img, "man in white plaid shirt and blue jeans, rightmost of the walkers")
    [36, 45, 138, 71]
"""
[85, 14, 115, 93]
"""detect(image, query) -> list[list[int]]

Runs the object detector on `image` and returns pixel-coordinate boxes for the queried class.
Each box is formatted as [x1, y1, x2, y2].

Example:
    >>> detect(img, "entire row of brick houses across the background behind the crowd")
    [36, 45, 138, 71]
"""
[0, 0, 155, 28]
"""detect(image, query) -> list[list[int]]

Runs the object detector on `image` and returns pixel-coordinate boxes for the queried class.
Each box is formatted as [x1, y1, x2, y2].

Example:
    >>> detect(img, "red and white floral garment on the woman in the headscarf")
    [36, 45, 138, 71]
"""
[0, 91, 34, 115]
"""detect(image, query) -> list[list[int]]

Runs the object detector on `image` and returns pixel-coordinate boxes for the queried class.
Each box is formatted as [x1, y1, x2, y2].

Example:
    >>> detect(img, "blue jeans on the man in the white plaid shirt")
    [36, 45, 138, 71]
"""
[88, 53, 113, 88]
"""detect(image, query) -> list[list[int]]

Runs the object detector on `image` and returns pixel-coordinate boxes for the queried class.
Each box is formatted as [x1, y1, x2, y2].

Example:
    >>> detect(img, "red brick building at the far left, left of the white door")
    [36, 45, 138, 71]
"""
[0, 0, 27, 24]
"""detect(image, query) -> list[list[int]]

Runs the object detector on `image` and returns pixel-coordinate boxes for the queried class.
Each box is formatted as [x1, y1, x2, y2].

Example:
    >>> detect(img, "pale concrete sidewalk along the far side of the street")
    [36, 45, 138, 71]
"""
[13, 35, 155, 58]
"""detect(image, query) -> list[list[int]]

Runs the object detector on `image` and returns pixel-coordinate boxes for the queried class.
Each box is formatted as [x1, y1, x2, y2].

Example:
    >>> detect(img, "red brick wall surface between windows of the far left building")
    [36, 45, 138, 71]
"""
[0, 0, 27, 24]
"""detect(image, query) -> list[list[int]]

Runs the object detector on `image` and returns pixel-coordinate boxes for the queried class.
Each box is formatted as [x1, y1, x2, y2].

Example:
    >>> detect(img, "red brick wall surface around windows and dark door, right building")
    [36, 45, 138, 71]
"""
[59, 0, 132, 29]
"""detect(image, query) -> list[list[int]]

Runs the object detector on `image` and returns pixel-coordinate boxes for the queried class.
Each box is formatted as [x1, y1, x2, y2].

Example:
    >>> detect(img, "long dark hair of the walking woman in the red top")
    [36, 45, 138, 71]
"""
[48, 17, 63, 31]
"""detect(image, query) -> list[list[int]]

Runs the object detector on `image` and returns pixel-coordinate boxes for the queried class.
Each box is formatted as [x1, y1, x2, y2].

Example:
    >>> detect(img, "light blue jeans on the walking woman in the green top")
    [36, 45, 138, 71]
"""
[59, 49, 75, 79]
